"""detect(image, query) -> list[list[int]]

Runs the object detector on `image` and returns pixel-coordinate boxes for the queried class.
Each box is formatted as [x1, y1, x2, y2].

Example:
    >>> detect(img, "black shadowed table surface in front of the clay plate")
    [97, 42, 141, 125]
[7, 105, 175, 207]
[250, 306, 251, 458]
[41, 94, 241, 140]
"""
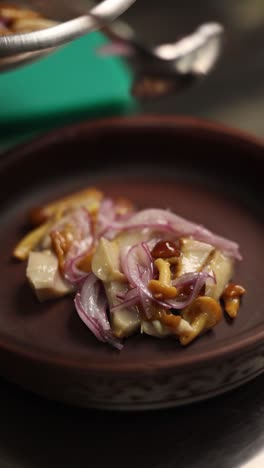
[0, 376, 264, 468]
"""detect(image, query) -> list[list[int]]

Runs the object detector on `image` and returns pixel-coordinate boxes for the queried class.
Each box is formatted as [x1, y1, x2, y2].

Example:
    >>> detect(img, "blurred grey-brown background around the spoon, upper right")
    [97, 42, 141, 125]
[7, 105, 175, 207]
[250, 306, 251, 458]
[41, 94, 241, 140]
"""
[124, 0, 264, 136]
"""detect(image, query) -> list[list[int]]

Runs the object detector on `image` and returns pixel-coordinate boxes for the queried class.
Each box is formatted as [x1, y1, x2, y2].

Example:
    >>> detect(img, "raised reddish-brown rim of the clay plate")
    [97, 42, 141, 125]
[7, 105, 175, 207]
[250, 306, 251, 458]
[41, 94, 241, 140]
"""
[0, 114, 264, 375]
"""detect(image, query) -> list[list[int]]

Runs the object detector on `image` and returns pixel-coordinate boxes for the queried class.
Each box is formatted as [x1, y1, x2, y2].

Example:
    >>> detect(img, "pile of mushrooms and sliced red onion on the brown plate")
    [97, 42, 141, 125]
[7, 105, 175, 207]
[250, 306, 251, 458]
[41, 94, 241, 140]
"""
[13, 188, 246, 349]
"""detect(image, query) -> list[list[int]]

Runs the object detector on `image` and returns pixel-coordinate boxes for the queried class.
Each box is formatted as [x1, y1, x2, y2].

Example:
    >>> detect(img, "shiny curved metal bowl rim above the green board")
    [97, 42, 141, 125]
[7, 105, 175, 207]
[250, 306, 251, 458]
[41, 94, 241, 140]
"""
[0, 0, 135, 70]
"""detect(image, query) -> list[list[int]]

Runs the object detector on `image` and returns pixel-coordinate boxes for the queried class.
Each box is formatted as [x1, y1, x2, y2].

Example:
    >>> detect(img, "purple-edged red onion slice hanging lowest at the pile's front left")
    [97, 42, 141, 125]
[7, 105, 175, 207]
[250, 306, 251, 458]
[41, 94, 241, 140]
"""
[74, 273, 123, 350]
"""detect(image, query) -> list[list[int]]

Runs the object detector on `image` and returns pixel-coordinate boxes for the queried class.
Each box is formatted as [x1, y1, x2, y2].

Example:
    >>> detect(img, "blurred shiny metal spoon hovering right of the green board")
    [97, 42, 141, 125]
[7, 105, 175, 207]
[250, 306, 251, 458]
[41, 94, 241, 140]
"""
[101, 21, 224, 99]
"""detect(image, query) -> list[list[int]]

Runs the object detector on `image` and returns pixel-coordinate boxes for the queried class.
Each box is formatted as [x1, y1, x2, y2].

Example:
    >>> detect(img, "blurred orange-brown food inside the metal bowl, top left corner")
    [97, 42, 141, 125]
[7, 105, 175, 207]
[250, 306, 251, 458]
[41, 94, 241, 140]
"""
[0, 1, 57, 36]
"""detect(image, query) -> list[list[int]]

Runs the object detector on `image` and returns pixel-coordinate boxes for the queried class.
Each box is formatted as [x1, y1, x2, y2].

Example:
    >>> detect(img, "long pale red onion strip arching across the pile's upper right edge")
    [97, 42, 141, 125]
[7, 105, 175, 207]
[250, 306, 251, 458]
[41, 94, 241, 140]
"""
[102, 209, 242, 260]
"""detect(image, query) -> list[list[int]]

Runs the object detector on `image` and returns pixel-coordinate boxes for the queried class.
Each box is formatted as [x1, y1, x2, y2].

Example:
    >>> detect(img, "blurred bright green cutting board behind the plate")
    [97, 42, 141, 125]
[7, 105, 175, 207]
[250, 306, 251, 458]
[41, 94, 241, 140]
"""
[0, 33, 135, 150]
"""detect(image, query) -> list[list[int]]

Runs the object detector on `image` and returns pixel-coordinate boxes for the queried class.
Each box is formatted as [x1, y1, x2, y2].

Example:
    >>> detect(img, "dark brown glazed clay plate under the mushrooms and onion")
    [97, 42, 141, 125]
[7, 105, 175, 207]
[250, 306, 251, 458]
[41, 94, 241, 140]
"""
[0, 117, 264, 409]
